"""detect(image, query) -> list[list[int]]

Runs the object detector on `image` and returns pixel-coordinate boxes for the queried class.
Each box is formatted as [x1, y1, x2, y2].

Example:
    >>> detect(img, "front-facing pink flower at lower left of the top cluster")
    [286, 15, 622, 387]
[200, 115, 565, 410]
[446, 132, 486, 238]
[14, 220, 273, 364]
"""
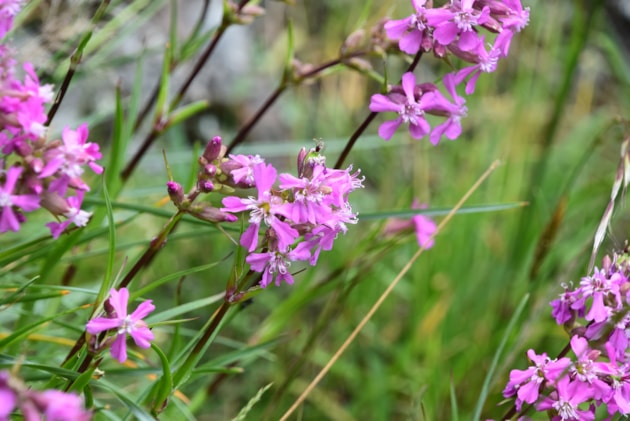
[370, 72, 434, 140]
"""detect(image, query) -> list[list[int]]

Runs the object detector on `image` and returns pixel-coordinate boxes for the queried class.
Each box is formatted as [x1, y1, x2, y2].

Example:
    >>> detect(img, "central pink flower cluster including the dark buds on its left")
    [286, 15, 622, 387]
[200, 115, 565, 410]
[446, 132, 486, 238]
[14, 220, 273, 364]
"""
[167, 136, 363, 288]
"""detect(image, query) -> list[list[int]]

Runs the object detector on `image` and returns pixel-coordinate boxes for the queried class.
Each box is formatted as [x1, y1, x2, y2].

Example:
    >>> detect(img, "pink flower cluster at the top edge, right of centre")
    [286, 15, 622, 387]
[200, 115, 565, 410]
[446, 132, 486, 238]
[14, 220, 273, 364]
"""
[370, 0, 529, 145]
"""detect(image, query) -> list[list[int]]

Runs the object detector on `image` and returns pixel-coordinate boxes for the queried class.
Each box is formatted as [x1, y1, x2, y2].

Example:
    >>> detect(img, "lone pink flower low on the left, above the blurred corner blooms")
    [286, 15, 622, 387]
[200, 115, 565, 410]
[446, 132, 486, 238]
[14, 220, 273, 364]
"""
[86, 288, 155, 363]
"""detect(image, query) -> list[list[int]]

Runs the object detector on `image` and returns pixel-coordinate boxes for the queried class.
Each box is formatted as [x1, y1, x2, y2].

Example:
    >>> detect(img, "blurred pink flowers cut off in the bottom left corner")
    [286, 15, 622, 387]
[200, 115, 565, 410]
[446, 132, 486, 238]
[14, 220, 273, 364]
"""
[0, 371, 92, 421]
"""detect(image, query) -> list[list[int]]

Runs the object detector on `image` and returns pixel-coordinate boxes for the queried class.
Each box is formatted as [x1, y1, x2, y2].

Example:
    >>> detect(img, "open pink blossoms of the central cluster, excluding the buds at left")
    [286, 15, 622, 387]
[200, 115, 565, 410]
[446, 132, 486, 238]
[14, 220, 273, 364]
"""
[221, 148, 363, 288]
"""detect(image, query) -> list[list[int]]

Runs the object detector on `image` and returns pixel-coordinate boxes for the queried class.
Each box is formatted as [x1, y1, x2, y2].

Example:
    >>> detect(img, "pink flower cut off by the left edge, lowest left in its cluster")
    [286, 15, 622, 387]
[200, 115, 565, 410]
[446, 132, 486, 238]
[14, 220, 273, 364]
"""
[0, 167, 39, 232]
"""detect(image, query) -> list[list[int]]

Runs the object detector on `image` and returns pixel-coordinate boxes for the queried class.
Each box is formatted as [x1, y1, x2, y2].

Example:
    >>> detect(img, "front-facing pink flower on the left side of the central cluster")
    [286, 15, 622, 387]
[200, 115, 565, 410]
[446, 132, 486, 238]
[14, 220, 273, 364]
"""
[221, 162, 298, 252]
